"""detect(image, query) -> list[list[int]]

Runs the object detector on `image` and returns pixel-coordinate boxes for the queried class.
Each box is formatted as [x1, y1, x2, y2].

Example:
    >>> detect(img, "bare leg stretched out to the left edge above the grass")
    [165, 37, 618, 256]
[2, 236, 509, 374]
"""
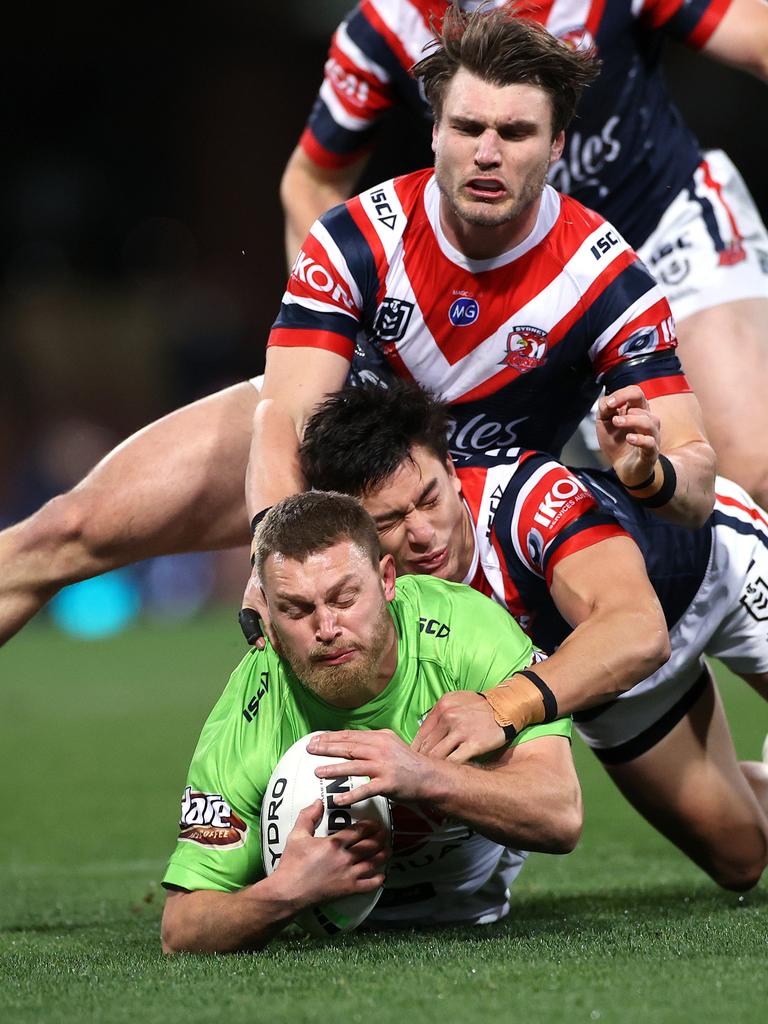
[0, 383, 258, 644]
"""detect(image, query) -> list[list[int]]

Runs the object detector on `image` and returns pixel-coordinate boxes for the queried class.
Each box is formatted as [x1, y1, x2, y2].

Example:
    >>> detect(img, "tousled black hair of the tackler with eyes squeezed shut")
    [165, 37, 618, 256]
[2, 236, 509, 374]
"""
[299, 380, 450, 497]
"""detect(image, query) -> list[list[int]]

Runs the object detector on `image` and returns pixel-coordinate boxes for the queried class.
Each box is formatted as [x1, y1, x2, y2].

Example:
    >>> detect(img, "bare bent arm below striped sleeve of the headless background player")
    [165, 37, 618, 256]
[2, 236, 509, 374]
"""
[280, 145, 368, 267]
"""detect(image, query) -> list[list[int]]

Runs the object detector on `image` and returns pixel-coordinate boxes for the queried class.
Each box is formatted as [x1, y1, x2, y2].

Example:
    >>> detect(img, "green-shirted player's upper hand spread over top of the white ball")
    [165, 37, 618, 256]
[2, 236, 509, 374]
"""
[307, 729, 439, 807]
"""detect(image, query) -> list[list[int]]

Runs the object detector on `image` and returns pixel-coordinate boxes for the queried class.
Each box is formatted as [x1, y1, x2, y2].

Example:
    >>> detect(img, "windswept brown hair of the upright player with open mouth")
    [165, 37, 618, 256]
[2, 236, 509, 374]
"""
[411, 2, 600, 138]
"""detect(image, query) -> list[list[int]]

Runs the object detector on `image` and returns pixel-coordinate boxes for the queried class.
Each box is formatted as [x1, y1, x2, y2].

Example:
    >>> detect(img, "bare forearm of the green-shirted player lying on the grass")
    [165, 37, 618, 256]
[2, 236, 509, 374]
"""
[161, 872, 302, 953]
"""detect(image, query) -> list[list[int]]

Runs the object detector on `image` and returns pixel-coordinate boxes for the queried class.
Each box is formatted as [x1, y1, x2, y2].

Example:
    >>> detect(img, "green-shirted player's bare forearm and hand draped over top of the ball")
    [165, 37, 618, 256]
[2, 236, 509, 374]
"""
[308, 729, 582, 853]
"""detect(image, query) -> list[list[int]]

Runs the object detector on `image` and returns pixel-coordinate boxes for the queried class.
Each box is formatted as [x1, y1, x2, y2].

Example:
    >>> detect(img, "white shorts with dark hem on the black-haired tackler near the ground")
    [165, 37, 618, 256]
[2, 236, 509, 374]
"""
[574, 477, 768, 764]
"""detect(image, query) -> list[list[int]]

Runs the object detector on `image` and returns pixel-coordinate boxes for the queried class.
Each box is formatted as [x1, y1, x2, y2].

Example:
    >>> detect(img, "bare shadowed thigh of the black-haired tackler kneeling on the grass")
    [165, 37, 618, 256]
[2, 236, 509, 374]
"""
[606, 680, 768, 888]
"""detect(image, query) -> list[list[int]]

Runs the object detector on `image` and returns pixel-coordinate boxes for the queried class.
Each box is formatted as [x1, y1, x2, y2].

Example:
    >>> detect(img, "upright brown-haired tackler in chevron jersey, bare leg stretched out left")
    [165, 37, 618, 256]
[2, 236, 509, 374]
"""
[0, 4, 714, 642]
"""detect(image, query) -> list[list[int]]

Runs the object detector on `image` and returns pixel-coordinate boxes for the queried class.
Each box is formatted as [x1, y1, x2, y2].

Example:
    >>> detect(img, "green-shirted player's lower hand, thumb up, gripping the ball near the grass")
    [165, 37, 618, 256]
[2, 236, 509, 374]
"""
[272, 800, 389, 911]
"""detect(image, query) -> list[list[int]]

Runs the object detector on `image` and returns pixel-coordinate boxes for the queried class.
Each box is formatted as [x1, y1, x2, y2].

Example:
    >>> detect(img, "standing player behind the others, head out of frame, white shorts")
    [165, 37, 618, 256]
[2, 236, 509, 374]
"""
[281, 0, 768, 507]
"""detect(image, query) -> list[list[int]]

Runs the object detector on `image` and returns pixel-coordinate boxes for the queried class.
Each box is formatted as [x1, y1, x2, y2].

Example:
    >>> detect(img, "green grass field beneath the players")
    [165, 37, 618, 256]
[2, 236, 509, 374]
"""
[0, 614, 768, 1024]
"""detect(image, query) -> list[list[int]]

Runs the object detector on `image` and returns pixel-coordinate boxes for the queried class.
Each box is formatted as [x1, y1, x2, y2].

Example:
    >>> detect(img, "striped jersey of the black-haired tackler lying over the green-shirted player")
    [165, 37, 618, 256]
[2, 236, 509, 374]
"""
[458, 451, 768, 653]
